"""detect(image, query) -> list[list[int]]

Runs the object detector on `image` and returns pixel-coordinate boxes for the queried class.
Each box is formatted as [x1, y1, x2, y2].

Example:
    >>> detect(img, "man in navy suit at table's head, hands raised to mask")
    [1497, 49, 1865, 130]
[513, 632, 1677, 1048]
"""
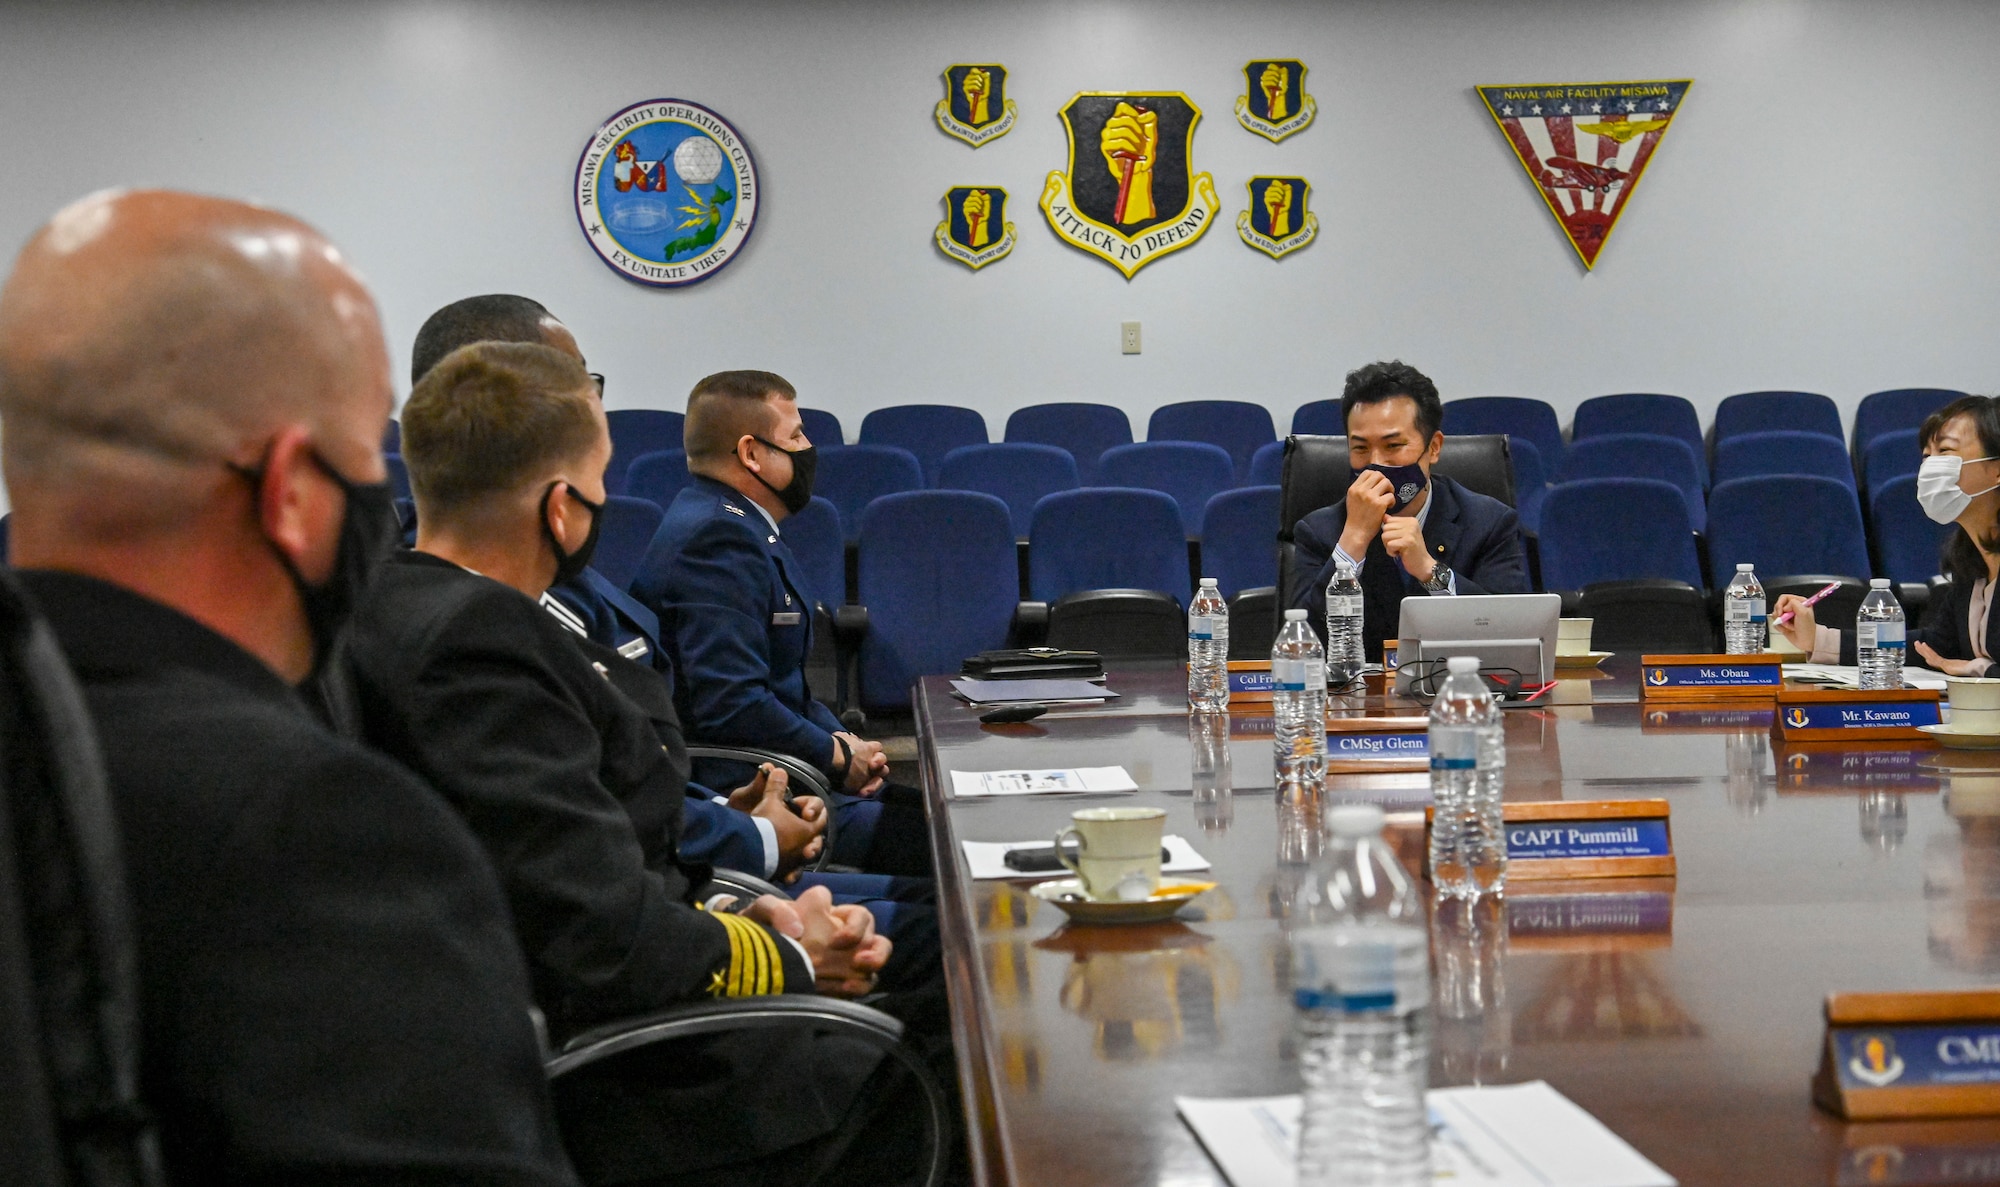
[1286, 362, 1530, 661]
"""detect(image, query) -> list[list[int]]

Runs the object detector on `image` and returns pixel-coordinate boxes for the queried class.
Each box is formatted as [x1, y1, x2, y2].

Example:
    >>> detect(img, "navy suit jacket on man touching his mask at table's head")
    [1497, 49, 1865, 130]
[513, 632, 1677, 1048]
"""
[1284, 474, 1534, 659]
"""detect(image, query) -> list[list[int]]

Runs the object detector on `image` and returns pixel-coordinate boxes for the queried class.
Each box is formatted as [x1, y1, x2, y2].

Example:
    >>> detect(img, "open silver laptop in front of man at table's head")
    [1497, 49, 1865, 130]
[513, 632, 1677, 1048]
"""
[1396, 594, 1562, 693]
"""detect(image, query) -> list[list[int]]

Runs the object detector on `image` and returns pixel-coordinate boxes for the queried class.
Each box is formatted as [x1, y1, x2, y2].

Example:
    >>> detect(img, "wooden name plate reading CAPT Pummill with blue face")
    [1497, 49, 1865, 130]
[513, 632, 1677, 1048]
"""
[1424, 799, 1674, 883]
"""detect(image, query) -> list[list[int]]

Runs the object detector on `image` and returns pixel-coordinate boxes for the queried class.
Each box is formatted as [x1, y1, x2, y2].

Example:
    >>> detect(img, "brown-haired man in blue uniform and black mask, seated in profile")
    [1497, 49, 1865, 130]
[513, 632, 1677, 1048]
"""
[632, 372, 930, 875]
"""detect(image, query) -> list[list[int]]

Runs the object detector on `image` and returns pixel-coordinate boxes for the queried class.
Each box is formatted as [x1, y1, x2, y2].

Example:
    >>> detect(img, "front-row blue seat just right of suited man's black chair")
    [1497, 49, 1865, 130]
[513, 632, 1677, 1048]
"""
[1540, 478, 1704, 590]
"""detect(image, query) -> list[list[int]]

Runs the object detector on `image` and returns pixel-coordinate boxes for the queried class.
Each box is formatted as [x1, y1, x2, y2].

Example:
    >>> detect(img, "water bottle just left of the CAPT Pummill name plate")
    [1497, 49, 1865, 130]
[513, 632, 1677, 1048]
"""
[1430, 655, 1506, 899]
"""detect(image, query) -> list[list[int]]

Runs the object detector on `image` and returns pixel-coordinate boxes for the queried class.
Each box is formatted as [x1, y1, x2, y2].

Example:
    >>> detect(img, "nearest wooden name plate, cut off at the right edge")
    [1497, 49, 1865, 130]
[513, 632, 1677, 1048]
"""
[1812, 989, 2000, 1121]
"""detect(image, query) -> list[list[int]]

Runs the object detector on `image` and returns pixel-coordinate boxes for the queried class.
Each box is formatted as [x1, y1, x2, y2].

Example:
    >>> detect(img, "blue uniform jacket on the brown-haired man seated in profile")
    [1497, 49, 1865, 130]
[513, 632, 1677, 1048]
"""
[632, 476, 842, 785]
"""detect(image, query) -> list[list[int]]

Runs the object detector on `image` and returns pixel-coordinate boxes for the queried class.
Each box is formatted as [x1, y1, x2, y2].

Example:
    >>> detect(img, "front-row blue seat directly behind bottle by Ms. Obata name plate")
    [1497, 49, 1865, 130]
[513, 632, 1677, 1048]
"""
[1704, 474, 1870, 588]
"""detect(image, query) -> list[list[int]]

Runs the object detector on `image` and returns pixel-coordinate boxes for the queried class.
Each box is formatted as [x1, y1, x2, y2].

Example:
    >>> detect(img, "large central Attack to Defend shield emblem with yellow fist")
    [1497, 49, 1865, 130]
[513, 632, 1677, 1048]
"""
[1040, 90, 1222, 280]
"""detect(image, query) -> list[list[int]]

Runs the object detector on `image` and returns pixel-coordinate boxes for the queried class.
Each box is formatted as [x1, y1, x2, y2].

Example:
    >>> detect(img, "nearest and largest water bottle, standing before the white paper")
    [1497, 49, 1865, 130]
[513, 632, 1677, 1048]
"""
[1290, 803, 1430, 1187]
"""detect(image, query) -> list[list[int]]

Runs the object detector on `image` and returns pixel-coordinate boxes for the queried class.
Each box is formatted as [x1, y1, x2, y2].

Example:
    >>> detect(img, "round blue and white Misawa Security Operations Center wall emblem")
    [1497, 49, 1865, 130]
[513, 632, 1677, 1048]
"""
[576, 100, 758, 288]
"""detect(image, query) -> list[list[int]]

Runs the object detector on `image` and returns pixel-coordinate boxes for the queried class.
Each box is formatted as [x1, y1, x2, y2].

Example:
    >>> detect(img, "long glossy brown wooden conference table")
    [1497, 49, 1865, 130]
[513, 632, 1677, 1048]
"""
[916, 655, 2000, 1187]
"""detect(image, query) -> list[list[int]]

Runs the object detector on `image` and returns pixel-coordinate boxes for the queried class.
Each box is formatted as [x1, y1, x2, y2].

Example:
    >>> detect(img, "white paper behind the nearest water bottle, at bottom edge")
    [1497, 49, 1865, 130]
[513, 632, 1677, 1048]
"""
[1174, 1081, 1676, 1187]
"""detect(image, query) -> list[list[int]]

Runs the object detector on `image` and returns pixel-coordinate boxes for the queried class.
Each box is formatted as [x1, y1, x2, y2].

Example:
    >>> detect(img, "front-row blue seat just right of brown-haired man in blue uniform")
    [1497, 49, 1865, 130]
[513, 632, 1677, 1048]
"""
[856, 490, 1024, 709]
